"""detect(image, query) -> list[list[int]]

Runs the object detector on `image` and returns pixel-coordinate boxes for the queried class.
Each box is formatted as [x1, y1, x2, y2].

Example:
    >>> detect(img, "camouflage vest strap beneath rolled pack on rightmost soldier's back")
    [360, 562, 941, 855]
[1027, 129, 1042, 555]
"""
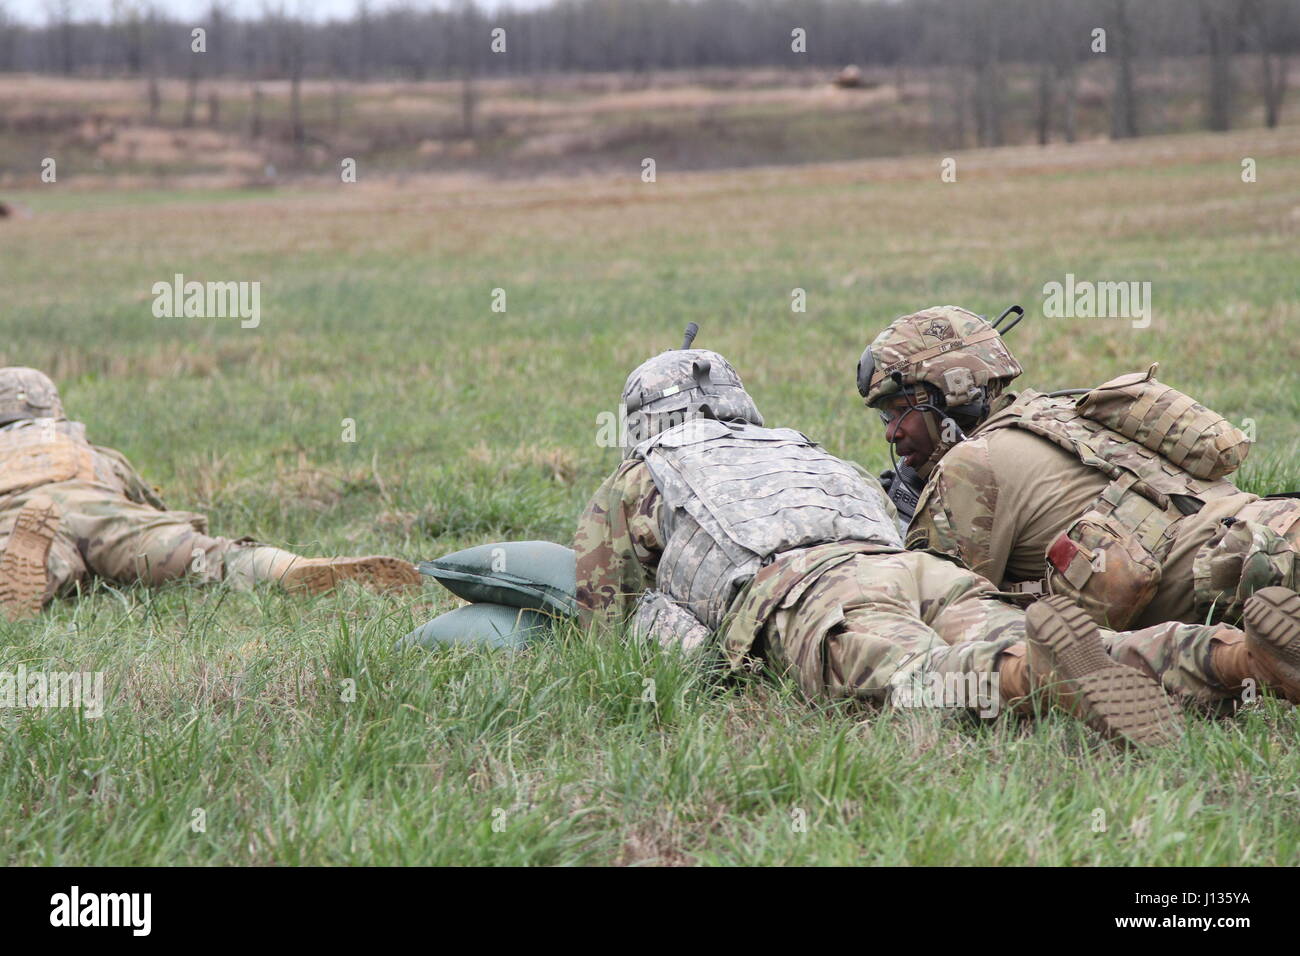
[975, 389, 1240, 559]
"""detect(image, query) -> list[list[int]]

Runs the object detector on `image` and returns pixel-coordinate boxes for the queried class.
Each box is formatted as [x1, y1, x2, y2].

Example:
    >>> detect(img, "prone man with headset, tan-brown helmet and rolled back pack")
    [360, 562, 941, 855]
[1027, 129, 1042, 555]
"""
[858, 306, 1300, 704]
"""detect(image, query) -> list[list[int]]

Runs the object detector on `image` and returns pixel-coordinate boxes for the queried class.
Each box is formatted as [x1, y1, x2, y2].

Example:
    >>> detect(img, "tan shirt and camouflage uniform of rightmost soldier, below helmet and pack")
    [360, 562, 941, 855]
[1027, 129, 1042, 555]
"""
[907, 392, 1300, 626]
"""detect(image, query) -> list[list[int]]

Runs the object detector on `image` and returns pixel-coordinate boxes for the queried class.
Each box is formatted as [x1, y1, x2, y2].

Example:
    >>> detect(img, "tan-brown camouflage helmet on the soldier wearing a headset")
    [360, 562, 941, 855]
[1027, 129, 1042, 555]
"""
[858, 306, 1022, 408]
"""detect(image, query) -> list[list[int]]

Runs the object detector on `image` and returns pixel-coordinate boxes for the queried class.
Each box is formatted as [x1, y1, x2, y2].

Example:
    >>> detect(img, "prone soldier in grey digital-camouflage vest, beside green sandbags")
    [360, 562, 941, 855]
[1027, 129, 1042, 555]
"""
[573, 335, 1300, 743]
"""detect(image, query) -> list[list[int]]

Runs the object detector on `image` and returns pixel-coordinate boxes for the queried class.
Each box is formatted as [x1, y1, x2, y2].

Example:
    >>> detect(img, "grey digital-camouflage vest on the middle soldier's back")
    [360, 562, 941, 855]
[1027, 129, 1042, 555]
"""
[633, 419, 902, 630]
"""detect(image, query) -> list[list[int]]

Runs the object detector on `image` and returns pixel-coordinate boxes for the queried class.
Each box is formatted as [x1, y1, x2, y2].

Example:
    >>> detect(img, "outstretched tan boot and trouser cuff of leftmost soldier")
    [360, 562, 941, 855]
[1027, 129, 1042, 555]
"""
[225, 545, 420, 594]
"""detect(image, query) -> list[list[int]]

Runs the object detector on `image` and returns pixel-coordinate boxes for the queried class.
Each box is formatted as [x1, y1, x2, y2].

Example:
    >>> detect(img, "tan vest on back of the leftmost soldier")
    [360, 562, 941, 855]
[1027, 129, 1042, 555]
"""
[0, 419, 122, 496]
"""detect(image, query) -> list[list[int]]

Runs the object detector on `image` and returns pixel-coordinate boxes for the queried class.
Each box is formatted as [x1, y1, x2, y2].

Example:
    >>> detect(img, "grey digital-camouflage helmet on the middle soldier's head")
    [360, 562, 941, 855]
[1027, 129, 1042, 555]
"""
[621, 323, 763, 458]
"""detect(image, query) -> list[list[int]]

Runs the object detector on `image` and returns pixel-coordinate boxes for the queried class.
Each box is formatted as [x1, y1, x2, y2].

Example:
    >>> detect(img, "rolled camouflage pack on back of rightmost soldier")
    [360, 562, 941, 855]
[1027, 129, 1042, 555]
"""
[1075, 364, 1251, 481]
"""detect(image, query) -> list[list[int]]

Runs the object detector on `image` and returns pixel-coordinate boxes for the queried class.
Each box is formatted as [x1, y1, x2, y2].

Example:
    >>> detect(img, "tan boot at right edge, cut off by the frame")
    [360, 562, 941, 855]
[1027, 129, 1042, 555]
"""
[1210, 588, 1300, 704]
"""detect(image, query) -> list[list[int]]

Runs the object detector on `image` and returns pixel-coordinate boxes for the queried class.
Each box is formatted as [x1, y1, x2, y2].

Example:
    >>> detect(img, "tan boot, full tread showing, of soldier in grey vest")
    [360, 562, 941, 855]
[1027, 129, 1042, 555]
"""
[1024, 594, 1183, 745]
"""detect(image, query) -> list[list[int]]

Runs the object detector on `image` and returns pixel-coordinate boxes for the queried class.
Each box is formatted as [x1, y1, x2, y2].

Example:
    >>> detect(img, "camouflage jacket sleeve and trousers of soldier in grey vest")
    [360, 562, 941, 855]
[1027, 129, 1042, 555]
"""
[573, 460, 1239, 704]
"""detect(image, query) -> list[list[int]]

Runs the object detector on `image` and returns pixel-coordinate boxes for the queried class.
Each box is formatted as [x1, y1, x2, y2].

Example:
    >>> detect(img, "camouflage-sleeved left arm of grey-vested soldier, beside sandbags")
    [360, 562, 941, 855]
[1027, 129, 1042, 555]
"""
[573, 460, 663, 627]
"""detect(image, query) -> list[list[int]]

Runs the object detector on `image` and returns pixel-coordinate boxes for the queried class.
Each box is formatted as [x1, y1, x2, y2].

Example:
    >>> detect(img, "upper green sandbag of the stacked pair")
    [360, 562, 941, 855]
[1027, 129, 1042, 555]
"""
[420, 541, 577, 617]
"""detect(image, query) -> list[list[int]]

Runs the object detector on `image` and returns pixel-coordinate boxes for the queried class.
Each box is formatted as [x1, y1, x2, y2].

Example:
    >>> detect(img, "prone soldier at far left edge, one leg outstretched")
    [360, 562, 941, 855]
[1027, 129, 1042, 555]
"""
[0, 368, 419, 620]
